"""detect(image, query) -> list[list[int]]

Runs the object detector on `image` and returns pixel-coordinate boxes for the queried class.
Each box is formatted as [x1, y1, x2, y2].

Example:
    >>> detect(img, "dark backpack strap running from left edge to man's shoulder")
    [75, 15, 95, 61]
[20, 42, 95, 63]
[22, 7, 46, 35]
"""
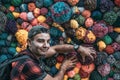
[0, 55, 30, 68]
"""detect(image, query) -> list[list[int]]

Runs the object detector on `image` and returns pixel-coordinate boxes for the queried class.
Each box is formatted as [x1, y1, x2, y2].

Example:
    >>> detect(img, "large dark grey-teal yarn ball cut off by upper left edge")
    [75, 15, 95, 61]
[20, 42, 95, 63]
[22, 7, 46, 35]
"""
[0, 11, 7, 32]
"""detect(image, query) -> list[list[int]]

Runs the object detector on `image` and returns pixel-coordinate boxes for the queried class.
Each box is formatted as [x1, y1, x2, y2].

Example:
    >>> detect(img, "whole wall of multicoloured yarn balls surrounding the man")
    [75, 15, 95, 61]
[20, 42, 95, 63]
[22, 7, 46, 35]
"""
[0, 0, 120, 80]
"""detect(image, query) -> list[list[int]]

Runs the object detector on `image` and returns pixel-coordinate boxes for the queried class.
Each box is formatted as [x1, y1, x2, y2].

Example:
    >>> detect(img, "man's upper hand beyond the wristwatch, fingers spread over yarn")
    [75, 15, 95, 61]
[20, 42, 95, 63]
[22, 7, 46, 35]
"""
[77, 46, 96, 62]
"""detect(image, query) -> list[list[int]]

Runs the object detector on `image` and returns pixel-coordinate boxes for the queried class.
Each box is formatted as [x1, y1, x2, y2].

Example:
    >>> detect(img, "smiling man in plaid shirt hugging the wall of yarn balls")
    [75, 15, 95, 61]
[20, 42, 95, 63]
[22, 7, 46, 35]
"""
[11, 26, 95, 80]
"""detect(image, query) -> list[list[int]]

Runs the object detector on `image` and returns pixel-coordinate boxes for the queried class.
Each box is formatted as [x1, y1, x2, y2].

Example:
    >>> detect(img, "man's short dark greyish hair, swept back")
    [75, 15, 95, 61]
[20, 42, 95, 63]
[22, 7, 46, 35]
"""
[28, 26, 49, 39]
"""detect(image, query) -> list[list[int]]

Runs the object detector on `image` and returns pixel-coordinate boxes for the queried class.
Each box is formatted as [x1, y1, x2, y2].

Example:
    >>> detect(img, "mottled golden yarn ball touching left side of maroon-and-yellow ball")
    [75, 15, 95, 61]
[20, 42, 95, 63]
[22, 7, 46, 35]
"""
[75, 27, 87, 40]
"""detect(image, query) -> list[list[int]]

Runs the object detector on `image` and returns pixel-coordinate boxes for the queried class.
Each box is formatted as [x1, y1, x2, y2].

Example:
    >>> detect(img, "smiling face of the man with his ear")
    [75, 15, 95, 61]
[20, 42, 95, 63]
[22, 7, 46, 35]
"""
[28, 33, 50, 56]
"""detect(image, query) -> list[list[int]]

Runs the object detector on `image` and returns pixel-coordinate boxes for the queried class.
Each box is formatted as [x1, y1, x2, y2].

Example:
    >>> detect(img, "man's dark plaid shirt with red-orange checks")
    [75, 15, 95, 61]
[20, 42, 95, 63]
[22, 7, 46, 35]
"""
[10, 50, 47, 80]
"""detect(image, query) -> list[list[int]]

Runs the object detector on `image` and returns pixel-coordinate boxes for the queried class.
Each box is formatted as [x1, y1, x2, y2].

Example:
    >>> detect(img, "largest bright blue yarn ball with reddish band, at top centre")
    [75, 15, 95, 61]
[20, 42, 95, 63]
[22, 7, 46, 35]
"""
[50, 2, 72, 24]
